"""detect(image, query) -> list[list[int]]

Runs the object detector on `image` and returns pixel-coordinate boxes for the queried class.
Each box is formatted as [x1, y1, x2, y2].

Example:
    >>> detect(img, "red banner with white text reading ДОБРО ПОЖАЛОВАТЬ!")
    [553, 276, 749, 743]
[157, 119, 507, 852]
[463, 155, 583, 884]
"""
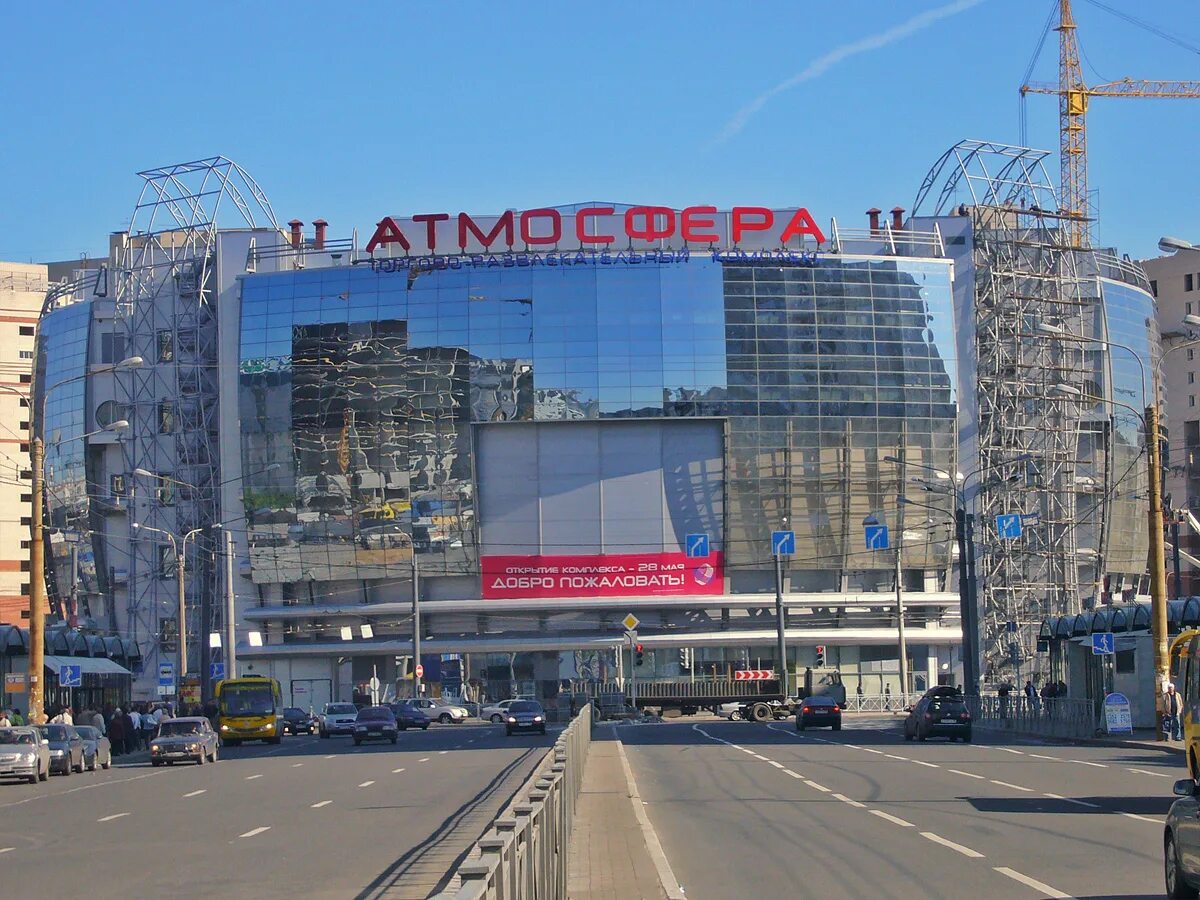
[480, 552, 725, 600]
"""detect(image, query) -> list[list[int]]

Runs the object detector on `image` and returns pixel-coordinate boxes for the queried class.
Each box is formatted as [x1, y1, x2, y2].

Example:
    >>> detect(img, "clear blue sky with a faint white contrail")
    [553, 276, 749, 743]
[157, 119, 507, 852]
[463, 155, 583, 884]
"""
[0, 0, 1200, 260]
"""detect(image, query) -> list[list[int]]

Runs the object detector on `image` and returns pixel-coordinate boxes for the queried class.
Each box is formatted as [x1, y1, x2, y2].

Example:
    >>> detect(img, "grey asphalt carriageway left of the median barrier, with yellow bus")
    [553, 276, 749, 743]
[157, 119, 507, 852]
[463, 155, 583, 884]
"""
[0, 725, 557, 900]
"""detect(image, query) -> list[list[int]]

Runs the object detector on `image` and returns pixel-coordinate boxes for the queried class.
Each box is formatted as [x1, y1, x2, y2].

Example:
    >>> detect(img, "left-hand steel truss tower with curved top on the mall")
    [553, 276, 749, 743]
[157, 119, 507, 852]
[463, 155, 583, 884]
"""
[114, 156, 278, 686]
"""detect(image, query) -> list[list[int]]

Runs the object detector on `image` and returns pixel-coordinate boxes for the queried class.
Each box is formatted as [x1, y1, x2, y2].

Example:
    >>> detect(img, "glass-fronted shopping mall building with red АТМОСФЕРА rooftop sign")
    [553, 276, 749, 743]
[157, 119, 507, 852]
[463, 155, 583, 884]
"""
[25, 148, 1158, 706]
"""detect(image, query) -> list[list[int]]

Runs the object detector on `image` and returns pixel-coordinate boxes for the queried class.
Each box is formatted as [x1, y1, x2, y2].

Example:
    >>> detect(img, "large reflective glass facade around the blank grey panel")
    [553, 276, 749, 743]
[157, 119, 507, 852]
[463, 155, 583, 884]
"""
[239, 254, 956, 590]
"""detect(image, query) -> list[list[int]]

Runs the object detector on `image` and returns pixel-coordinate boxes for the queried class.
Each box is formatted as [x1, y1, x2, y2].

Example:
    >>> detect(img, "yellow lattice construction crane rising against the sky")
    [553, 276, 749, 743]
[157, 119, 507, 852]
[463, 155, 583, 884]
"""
[1021, 0, 1200, 247]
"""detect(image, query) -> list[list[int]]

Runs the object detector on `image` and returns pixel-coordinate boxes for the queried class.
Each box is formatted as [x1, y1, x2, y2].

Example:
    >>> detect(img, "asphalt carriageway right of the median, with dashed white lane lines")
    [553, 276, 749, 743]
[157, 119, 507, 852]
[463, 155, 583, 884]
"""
[619, 716, 1186, 900]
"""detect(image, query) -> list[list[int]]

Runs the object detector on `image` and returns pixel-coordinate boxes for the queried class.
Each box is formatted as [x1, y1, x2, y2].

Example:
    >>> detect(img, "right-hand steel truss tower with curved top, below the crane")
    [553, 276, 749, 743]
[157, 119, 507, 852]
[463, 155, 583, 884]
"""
[917, 140, 1108, 679]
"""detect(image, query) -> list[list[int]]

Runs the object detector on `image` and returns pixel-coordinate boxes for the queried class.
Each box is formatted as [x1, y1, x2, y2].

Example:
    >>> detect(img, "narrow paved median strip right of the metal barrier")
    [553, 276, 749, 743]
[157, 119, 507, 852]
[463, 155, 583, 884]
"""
[566, 726, 667, 900]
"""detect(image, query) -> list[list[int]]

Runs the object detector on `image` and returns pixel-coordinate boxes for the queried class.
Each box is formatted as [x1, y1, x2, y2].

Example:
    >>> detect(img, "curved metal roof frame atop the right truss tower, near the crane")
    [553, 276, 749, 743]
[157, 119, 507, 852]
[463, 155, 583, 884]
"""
[912, 140, 1058, 216]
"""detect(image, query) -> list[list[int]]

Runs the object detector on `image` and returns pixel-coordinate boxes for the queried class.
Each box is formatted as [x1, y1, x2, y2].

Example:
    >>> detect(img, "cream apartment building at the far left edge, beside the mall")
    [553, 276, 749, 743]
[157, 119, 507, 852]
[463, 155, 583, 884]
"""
[0, 262, 47, 624]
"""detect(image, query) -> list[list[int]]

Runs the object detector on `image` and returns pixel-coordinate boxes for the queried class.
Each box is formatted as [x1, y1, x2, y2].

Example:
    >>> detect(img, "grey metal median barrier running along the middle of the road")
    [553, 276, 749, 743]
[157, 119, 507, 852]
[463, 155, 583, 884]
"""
[437, 703, 592, 900]
